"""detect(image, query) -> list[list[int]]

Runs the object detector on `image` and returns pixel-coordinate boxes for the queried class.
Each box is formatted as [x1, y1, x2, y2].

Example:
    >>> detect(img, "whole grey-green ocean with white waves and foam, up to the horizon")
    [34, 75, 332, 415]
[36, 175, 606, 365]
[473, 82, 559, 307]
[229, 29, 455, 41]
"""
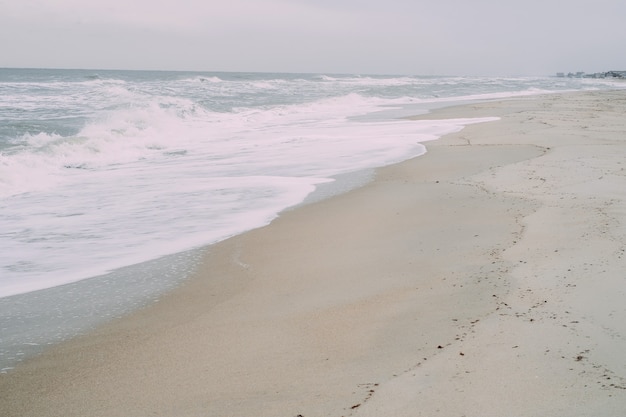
[0, 69, 616, 372]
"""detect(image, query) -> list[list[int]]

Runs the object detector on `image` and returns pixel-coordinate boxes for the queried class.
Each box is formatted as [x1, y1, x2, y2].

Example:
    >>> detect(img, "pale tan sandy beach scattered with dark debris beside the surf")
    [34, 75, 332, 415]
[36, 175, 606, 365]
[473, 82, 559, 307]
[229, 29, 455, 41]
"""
[0, 90, 626, 417]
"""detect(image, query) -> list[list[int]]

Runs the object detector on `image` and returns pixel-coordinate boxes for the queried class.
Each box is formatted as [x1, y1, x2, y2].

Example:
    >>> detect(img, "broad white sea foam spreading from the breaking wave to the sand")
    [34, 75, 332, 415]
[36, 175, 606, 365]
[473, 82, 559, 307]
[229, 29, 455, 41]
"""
[0, 95, 490, 295]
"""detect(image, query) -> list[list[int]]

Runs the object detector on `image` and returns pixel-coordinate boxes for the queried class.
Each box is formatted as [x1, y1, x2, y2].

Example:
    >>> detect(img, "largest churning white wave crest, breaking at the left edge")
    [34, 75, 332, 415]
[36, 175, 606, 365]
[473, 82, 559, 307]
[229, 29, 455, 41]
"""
[0, 99, 206, 196]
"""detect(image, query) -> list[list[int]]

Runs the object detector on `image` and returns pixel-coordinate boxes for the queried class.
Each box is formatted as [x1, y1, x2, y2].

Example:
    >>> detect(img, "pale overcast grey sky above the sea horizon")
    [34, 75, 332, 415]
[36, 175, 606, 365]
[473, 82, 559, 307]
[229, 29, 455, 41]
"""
[0, 0, 626, 76]
